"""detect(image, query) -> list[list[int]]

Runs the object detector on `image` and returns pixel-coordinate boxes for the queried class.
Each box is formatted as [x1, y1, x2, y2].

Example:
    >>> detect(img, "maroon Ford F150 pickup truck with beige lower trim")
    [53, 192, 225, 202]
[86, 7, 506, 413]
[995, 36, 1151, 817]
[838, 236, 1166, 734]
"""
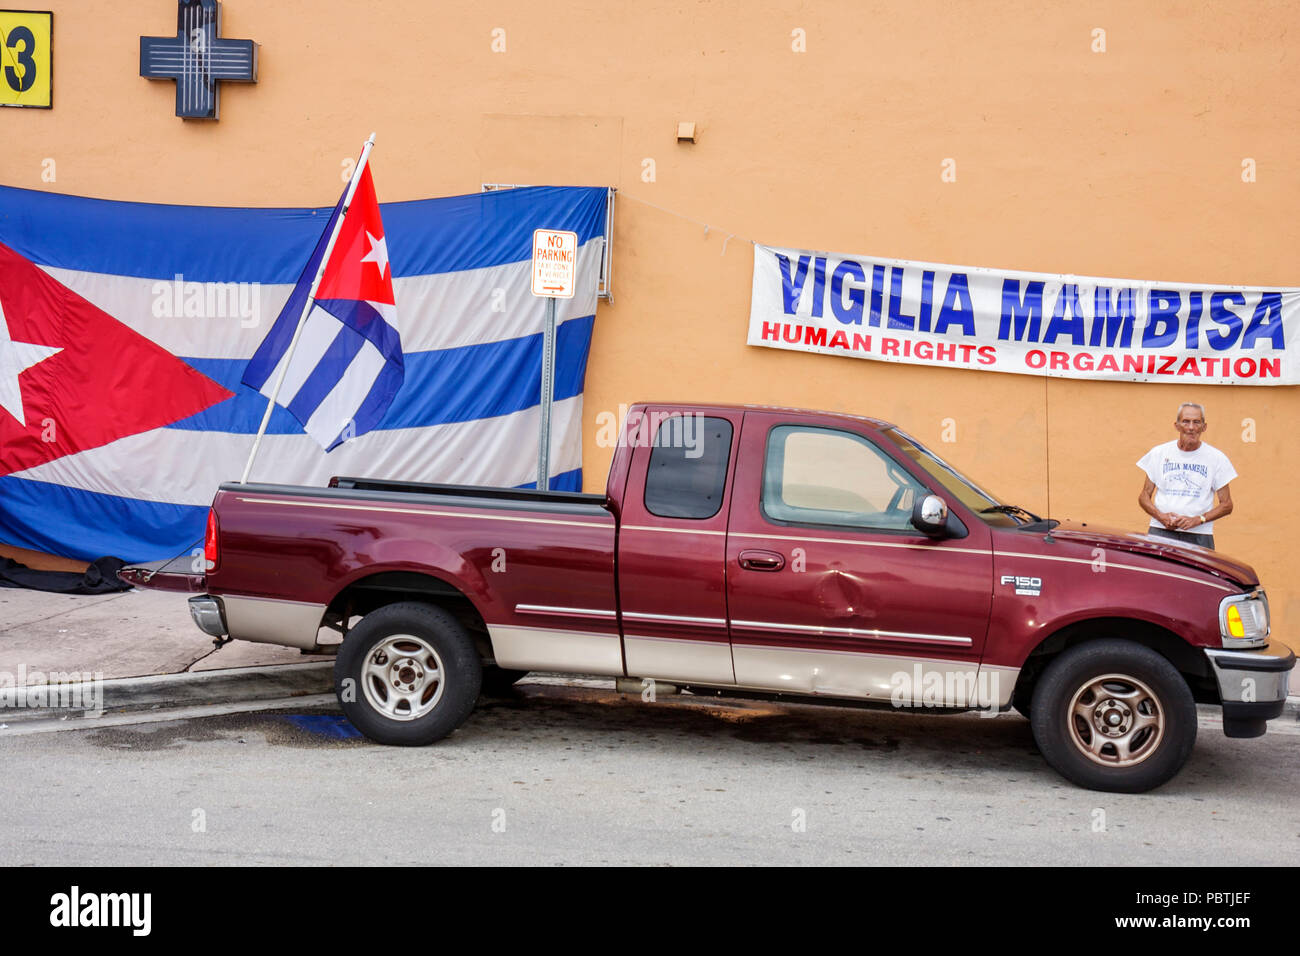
[124, 405, 1295, 792]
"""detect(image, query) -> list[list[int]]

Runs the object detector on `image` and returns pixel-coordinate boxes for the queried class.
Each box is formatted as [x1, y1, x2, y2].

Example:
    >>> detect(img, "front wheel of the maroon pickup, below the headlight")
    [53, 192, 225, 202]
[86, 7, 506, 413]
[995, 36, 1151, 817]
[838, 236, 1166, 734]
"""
[1030, 639, 1196, 793]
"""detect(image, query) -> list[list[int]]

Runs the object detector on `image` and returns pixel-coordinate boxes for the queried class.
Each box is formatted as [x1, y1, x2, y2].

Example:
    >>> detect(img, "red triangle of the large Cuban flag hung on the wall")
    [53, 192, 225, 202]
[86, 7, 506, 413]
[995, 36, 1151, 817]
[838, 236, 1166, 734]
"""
[0, 243, 233, 475]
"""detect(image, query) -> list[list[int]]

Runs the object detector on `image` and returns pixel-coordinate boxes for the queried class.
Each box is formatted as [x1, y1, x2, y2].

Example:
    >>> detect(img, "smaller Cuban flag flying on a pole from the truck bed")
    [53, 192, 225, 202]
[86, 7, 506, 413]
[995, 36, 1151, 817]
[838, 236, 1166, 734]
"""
[242, 143, 404, 451]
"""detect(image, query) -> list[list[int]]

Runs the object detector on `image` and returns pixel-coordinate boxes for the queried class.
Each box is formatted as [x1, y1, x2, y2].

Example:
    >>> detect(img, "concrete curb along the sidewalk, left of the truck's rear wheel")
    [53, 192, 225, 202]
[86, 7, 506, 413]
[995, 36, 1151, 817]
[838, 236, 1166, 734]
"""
[0, 661, 334, 726]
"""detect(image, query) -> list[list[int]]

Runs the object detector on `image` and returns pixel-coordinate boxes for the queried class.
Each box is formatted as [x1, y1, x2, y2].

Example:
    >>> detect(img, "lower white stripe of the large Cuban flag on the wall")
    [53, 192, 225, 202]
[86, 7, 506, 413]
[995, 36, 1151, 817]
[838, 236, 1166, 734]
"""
[5, 395, 582, 505]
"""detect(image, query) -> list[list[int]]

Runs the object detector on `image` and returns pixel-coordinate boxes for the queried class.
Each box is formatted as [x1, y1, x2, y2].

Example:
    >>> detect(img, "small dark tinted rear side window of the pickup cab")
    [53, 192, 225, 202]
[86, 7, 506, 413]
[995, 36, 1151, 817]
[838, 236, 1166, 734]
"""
[645, 415, 732, 519]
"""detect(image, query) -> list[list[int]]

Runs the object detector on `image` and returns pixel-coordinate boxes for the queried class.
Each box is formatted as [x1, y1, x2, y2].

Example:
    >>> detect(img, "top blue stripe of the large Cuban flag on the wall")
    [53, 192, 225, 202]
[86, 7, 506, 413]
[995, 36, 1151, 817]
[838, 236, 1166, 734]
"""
[0, 183, 606, 285]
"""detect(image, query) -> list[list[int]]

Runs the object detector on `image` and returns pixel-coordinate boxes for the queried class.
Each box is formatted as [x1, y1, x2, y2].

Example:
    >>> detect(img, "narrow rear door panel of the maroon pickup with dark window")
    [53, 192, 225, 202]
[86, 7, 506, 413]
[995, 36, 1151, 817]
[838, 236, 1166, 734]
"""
[619, 408, 741, 684]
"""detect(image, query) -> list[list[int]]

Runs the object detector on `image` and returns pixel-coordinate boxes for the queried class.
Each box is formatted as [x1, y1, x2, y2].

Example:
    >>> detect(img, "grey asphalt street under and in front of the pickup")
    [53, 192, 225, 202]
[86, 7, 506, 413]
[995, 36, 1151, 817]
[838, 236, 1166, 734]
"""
[0, 682, 1300, 866]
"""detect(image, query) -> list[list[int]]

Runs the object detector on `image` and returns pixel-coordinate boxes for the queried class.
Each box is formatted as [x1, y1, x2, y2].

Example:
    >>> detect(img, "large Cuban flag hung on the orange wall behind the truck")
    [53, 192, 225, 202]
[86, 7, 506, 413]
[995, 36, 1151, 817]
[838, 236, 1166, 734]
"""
[0, 186, 606, 561]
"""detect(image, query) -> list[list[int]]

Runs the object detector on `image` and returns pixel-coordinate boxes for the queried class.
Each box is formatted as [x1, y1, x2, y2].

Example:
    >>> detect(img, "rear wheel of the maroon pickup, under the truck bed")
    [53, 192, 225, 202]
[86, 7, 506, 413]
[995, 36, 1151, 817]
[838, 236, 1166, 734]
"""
[334, 601, 482, 747]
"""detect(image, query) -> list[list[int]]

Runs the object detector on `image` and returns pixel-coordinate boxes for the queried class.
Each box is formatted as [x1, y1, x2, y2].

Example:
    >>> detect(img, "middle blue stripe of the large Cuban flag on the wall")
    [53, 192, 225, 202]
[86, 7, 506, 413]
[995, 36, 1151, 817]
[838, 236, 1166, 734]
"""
[170, 316, 595, 434]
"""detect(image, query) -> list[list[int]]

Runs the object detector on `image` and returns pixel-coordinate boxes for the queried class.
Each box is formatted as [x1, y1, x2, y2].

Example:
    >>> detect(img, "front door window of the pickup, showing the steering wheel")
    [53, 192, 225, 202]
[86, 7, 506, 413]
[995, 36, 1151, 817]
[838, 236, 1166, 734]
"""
[763, 425, 926, 531]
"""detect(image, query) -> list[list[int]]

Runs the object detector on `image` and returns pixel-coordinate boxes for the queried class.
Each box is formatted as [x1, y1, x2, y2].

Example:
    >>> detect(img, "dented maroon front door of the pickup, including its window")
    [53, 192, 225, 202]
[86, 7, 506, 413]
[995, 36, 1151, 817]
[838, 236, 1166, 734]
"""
[727, 411, 993, 705]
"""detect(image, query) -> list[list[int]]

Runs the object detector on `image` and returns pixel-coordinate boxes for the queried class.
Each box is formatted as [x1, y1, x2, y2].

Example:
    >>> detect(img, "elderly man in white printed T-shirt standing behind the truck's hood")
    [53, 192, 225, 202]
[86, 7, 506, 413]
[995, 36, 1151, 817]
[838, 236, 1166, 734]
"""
[1138, 402, 1236, 549]
